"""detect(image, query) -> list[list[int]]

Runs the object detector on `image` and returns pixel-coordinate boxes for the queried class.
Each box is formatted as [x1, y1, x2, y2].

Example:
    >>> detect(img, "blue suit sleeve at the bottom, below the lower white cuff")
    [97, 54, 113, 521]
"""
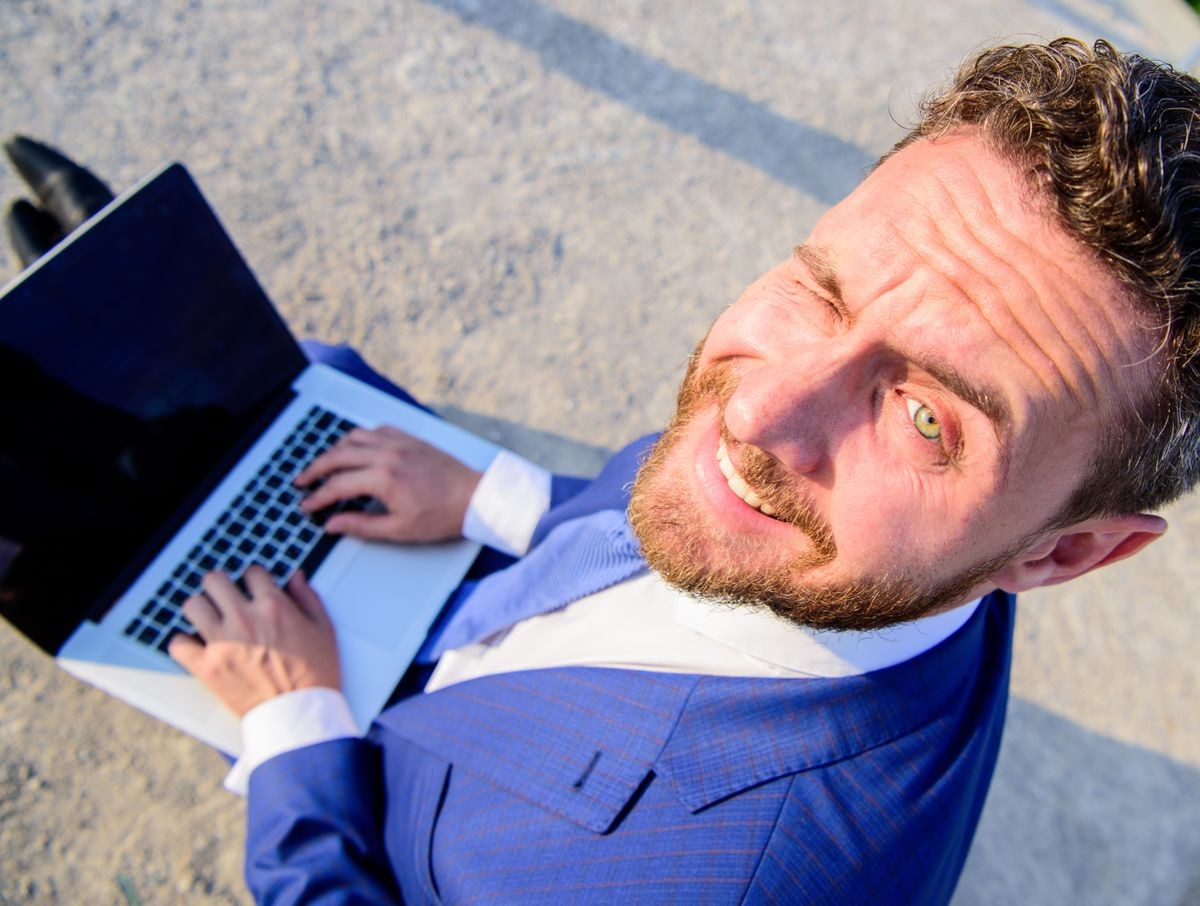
[246, 739, 401, 904]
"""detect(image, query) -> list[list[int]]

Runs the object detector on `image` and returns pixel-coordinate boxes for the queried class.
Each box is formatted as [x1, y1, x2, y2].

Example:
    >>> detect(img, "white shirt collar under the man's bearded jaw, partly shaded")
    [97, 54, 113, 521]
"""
[655, 575, 983, 677]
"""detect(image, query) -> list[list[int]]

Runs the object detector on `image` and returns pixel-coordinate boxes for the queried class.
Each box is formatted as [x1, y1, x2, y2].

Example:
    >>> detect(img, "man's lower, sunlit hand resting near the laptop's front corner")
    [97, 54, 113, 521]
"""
[170, 566, 341, 718]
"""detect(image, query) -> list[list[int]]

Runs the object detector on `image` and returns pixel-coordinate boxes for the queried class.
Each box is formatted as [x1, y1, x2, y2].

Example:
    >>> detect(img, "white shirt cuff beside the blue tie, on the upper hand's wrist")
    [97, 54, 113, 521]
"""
[462, 450, 551, 557]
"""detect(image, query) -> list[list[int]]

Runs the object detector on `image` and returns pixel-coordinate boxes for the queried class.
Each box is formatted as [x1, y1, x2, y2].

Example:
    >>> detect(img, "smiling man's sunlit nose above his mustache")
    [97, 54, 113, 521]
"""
[725, 340, 870, 475]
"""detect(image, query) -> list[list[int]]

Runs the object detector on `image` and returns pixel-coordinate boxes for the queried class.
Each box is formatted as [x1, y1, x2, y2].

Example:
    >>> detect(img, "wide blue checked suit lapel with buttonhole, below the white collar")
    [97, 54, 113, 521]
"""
[377, 594, 1012, 833]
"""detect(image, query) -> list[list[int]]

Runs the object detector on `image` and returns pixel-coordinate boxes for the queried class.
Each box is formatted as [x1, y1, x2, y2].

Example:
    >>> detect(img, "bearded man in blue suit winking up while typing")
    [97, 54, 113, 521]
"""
[159, 41, 1200, 904]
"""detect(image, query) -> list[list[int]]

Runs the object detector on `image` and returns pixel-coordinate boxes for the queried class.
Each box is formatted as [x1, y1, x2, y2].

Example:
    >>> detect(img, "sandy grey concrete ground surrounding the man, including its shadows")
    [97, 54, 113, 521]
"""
[0, 0, 1200, 906]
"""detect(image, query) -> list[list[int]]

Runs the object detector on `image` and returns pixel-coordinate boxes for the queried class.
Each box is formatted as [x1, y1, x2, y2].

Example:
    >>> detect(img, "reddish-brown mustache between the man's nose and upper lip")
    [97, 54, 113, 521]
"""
[672, 353, 838, 565]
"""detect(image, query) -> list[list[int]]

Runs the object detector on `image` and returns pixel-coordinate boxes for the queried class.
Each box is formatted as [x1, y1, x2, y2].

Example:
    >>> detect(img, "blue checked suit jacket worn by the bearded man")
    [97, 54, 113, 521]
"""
[246, 436, 1014, 905]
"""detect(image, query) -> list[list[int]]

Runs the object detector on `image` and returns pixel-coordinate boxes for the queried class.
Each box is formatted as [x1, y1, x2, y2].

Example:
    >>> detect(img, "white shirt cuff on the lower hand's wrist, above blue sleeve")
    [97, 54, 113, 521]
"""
[224, 688, 360, 796]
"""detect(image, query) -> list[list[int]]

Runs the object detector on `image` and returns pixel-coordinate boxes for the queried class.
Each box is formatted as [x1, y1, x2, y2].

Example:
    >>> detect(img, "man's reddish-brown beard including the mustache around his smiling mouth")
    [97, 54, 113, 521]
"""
[629, 341, 1016, 631]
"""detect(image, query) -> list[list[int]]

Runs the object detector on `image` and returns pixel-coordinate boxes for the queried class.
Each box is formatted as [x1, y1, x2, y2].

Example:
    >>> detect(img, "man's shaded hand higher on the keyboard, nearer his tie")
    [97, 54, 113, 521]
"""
[296, 427, 482, 541]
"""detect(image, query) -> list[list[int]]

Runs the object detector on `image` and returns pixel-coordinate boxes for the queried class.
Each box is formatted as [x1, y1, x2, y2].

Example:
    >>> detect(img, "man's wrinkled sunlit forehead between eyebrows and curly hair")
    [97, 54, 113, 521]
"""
[809, 133, 1160, 463]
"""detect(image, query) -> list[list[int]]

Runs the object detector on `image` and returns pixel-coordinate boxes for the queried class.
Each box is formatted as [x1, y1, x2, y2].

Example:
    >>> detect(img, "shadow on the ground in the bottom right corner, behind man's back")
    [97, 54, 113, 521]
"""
[954, 700, 1200, 906]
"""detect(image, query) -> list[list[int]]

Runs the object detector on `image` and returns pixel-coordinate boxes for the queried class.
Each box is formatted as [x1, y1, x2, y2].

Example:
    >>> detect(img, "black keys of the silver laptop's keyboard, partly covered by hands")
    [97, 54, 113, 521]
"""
[125, 406, 371, 653]
